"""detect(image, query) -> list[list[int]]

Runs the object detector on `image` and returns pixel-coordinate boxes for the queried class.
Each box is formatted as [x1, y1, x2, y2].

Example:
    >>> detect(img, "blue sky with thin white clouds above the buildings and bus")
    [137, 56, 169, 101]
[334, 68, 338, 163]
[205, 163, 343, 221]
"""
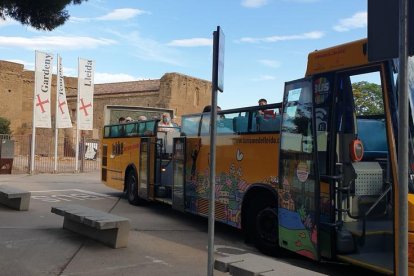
[0, 0, 367, 109]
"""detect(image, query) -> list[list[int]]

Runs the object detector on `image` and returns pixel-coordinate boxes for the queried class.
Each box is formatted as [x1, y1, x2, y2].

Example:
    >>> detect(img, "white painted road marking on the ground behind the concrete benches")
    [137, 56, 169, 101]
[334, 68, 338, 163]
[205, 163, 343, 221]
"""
[30, 189, 113, 202]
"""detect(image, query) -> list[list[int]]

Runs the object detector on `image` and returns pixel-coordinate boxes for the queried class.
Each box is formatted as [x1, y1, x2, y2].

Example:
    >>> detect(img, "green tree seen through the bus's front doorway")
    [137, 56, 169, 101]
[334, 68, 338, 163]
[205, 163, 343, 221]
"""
[352, 81, 384, 115]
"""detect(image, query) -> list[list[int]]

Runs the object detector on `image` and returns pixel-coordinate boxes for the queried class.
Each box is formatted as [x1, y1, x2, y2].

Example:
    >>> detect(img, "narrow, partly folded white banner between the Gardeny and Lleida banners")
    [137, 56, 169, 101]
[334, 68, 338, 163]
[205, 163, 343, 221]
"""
[56, 56, 72, 128]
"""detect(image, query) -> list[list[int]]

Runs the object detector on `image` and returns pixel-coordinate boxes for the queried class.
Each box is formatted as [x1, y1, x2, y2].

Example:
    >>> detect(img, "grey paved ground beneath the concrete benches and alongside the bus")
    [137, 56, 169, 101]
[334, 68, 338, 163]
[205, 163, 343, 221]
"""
[0, 173, 382, 276]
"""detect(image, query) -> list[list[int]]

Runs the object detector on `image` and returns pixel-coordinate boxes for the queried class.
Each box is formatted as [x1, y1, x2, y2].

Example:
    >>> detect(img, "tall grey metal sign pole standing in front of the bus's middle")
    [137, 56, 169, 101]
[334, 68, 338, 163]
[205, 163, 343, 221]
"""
[207, 28, 219, 276]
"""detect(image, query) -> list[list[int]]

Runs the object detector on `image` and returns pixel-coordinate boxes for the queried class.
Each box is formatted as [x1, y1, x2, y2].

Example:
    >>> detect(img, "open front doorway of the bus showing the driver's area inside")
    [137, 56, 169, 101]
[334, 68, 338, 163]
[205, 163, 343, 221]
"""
[334, 66, 397, 273]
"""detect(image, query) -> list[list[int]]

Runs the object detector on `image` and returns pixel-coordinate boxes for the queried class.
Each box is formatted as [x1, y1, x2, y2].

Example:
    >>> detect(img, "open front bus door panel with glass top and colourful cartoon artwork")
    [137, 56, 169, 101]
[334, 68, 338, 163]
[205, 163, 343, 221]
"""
[278, 78, 320, 260]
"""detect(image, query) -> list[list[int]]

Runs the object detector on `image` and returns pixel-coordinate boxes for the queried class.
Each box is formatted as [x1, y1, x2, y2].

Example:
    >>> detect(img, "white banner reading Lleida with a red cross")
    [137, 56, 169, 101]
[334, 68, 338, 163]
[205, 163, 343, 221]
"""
[77, 58, 95, 130]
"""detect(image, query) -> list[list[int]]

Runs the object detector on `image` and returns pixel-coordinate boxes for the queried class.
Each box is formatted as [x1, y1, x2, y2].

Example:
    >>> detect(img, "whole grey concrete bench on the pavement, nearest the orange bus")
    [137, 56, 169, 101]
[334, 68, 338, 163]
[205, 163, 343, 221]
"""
[51, 205, 130, 248]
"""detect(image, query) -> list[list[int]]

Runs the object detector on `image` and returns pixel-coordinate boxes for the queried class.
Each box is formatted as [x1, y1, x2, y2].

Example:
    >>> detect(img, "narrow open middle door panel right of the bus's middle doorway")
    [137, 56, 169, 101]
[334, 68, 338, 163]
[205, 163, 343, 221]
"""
[172, 137, 186, 212]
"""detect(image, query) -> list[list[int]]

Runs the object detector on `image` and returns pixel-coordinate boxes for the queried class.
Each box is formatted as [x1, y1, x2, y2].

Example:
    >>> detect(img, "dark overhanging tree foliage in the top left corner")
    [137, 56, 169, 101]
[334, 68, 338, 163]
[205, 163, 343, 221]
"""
[0, 0, 87, 31]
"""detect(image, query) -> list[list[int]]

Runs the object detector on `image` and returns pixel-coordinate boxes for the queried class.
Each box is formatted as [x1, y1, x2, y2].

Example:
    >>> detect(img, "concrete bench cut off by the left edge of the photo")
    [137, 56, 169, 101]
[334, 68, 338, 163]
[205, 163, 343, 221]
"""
[0, 185, 30, 211]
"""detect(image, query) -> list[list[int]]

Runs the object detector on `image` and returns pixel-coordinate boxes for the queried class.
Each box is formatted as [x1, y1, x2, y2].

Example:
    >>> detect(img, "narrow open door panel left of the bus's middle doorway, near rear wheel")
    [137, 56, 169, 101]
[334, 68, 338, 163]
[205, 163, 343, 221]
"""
[138, 137, 155, 200]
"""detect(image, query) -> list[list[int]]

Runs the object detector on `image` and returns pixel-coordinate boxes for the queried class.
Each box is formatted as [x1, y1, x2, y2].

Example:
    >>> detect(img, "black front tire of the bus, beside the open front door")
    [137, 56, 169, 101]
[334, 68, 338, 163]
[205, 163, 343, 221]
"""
[248, 197, 279, 255]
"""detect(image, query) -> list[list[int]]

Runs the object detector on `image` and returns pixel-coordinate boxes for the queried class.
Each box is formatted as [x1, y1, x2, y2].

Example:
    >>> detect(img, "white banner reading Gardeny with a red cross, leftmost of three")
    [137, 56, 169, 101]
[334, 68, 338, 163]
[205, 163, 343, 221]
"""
[33, 51, 53, 128]
